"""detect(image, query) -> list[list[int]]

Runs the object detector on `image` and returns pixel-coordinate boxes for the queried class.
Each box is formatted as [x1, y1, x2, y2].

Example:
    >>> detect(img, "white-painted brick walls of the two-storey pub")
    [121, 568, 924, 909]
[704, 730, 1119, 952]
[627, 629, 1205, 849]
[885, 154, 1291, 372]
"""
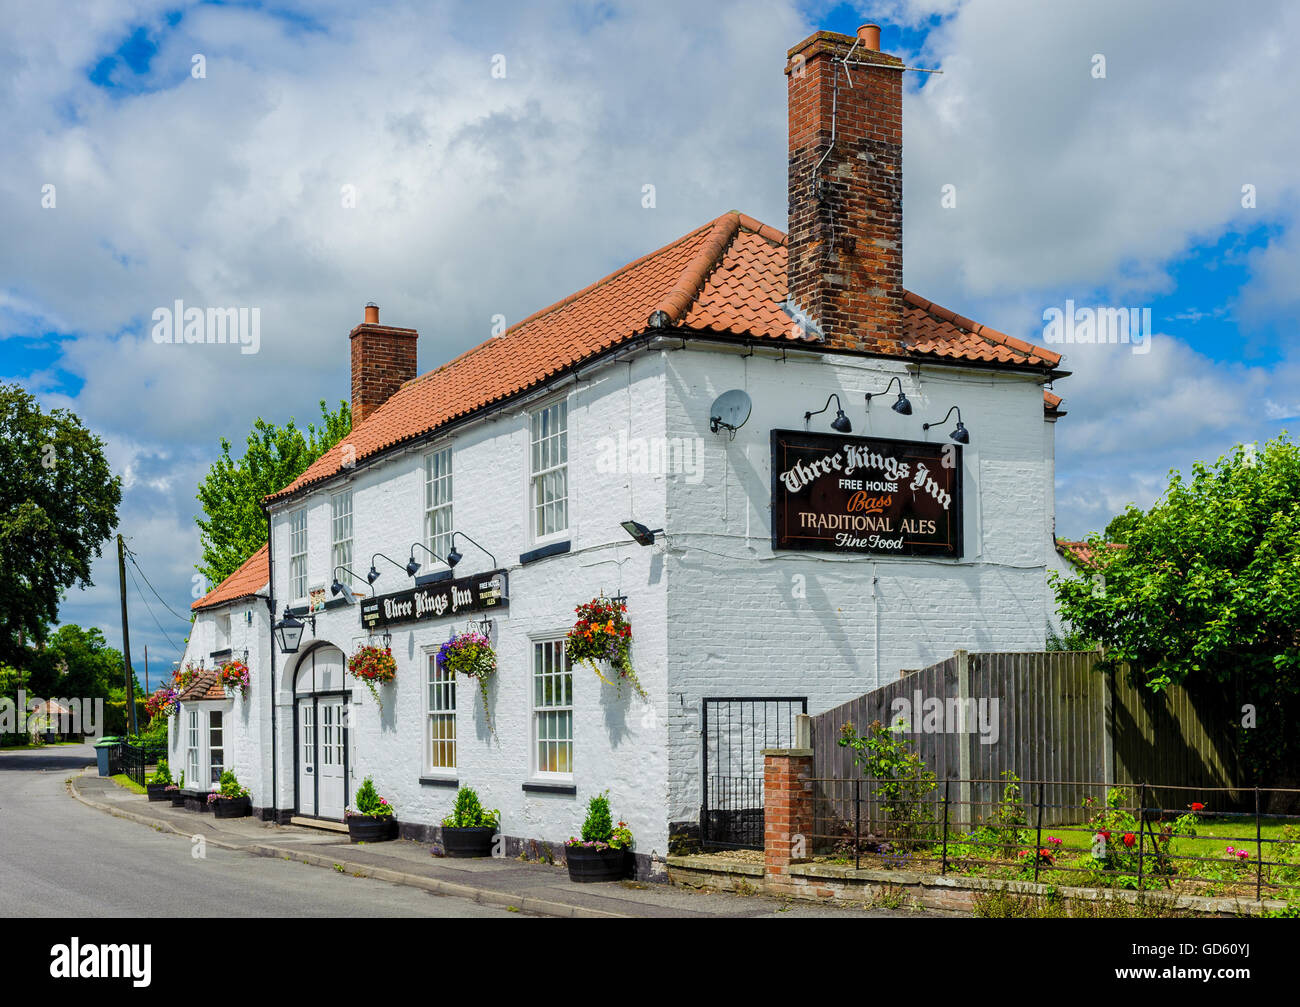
[202, 337, 1050, 854]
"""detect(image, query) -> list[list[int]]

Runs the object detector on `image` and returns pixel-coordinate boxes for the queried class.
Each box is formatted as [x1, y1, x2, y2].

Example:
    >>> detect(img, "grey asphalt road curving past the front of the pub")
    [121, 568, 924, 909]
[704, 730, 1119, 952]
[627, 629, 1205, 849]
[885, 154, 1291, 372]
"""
[0, 746, 525, 919]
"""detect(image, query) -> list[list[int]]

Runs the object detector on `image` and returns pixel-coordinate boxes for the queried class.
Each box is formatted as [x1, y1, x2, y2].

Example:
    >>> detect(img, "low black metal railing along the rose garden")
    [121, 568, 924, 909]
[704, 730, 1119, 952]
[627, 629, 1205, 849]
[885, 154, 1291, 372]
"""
[806, 777, 1300, 899]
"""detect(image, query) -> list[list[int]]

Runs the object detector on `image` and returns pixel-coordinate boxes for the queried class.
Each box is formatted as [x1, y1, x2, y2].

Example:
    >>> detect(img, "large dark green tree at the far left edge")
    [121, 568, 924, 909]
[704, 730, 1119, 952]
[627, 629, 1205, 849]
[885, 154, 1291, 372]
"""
[0, 385, 122, 665]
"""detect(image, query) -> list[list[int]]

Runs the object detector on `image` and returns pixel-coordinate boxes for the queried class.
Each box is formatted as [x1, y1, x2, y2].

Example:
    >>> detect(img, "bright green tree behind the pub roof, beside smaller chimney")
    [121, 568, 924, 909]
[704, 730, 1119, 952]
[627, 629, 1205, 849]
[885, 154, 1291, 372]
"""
[195, 399, 352, 587]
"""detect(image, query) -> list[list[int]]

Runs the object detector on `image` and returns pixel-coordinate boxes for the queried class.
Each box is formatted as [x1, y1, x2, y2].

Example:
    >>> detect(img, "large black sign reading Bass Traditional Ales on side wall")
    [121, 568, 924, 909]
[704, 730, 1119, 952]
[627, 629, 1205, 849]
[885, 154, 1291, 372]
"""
[772, 430, 962, 559]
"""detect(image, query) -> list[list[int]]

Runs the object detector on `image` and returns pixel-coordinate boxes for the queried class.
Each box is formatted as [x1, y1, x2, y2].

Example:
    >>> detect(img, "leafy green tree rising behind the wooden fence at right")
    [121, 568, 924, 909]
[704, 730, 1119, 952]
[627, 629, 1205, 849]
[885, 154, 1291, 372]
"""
[1056, 433, 1300, 786]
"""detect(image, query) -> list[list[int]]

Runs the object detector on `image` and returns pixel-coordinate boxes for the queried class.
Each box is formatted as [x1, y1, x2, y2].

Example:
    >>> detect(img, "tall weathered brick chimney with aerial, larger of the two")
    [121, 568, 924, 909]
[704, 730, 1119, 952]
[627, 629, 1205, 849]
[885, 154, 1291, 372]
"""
[785, 25, 904, 353]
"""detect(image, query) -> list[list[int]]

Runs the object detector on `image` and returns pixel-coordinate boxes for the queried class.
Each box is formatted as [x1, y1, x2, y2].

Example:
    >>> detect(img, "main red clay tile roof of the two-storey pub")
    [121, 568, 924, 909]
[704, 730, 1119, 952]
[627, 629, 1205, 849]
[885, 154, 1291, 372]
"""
[269, 210, 1061, 501]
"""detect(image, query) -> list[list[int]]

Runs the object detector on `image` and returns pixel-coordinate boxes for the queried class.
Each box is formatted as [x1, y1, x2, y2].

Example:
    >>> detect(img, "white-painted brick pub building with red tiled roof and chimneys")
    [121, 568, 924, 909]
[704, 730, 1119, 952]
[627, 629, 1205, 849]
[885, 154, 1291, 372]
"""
[172, 27, 1063, 873]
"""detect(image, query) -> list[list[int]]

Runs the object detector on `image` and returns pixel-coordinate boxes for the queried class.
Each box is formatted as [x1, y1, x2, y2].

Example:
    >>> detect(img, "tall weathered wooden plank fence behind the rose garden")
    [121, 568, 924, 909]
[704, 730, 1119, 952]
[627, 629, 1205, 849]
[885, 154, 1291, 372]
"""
[813, 651, 1248, 825]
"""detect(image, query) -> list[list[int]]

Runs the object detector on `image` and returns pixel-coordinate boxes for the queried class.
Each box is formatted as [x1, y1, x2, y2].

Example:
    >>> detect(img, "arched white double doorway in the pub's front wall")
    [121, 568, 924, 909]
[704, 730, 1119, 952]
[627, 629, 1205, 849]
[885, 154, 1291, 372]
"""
[294, 643, 351, 821]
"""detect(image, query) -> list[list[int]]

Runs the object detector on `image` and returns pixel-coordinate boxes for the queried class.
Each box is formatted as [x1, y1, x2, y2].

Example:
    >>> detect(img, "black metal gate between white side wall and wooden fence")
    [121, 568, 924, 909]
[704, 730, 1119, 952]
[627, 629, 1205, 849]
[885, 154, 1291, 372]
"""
[699, 696, 809, 850]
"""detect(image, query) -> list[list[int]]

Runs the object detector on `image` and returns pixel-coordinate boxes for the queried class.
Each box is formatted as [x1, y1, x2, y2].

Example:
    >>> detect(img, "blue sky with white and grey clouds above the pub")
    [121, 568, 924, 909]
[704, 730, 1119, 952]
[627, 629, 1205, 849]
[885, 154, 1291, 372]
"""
[0, 0, 1300, 675]
